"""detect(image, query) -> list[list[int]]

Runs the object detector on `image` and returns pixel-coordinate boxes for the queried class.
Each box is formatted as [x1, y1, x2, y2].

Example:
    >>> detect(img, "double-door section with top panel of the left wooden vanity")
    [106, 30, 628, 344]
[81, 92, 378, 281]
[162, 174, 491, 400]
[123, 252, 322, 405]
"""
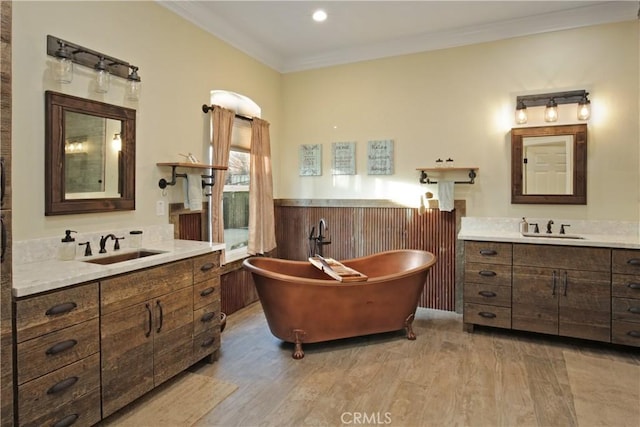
[100, 259, 193, 417]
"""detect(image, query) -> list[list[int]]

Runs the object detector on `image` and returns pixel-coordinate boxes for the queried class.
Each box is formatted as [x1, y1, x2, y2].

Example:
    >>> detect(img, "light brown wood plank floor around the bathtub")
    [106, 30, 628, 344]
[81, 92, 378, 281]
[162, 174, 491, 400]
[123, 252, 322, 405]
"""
[116, 303, 640, 427]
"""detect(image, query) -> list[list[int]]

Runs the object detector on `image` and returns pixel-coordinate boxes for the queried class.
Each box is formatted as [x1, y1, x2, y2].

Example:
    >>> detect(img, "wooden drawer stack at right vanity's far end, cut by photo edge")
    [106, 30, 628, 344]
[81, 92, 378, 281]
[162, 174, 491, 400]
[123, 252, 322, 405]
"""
[611, 249, 640, 347]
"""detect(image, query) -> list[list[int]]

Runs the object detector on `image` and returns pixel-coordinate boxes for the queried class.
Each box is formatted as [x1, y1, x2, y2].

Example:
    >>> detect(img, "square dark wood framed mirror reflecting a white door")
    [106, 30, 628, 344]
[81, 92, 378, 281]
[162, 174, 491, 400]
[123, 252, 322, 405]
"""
[511, 124, 587, 205]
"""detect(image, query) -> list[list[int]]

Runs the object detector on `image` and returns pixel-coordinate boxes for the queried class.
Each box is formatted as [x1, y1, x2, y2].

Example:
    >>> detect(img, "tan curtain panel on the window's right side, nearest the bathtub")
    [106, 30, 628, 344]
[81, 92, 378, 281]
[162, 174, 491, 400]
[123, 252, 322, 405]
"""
[247, 117, 276, 255]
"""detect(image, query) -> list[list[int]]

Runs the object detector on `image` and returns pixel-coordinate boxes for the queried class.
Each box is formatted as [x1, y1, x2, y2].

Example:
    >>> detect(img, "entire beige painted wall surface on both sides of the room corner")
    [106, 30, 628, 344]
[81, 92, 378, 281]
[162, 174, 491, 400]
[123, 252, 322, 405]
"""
[13, 2, 640, 240]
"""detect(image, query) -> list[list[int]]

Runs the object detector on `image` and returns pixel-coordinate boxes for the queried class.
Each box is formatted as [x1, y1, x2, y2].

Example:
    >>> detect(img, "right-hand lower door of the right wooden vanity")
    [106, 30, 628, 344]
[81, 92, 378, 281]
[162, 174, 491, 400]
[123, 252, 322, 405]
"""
[559, 270, 611, 342]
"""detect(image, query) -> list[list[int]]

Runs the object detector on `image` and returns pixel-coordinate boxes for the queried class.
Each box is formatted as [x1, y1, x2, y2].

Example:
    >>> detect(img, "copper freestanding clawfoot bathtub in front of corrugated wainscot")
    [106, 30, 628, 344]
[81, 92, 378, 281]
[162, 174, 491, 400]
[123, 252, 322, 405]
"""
[243, 249, 436, 359]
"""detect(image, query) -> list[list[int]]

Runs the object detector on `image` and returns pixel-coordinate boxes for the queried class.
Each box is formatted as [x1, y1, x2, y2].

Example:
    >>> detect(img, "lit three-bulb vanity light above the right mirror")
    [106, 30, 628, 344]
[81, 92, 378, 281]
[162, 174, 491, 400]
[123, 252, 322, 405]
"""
[515, 90, 591, 125]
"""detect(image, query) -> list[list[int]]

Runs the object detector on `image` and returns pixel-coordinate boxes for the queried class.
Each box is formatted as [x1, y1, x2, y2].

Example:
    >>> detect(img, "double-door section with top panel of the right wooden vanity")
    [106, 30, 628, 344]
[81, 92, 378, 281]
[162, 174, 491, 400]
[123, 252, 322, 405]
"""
[511, 244, 611, 342]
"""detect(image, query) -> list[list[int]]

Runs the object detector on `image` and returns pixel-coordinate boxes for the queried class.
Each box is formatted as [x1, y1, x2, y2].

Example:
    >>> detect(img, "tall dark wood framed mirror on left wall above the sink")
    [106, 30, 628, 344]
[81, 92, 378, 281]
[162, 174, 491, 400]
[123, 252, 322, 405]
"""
[45, 91, 136, 215]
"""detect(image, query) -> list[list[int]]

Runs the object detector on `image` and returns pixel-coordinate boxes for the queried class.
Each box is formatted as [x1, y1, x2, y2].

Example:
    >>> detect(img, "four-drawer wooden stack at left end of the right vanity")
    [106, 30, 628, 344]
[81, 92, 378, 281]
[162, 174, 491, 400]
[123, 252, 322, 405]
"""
[463, 242, 512, 332]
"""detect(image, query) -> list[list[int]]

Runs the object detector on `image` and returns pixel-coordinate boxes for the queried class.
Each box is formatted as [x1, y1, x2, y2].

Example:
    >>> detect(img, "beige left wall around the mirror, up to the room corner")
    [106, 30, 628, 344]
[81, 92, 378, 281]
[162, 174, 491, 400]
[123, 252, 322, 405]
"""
[13, 1, 282, 240]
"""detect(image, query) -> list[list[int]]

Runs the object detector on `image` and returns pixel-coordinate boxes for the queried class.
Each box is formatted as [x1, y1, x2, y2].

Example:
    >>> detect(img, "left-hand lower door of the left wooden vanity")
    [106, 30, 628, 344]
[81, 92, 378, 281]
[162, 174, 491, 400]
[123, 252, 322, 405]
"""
[100, 301, 154, 417]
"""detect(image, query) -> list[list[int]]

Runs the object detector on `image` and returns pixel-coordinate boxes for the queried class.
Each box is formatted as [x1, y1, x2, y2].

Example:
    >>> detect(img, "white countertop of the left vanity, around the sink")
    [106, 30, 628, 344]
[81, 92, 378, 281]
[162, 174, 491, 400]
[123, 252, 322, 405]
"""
[13, 240, 224, 297]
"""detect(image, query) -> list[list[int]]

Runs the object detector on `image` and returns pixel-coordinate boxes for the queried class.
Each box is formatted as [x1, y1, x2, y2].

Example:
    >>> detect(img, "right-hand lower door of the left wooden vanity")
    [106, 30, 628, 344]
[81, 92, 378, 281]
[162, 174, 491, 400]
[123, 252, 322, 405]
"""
[153, 288, 193, 386]
